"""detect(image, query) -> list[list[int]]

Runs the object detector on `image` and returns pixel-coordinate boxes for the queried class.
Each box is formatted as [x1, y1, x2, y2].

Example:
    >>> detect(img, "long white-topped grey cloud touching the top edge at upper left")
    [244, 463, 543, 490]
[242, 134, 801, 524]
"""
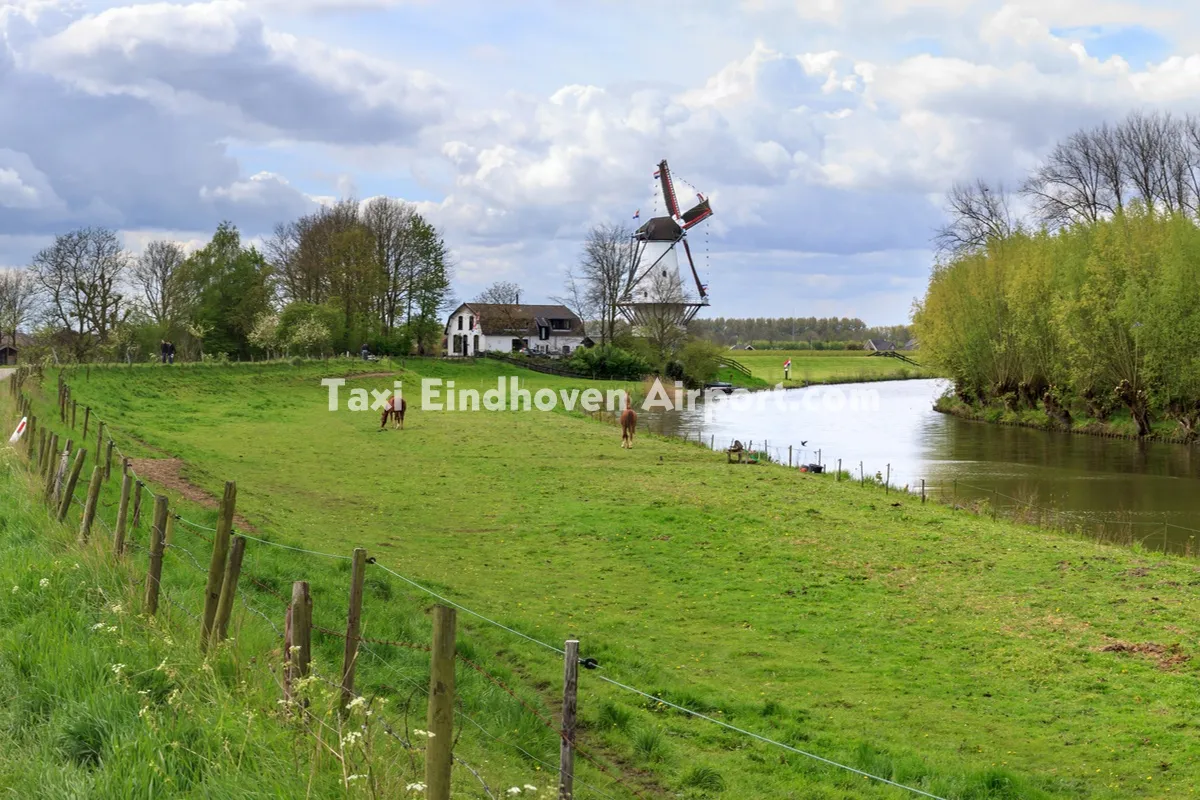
[30, 0, 443, 144]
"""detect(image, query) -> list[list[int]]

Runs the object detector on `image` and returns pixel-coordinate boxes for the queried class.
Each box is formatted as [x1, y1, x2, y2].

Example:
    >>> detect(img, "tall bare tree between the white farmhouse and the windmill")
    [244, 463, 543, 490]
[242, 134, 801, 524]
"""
[576, 224, 631, 344]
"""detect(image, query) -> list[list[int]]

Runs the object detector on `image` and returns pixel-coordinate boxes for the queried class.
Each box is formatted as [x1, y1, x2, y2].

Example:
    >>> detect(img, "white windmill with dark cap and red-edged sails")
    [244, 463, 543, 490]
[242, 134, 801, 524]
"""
[617, 158, 713, 329]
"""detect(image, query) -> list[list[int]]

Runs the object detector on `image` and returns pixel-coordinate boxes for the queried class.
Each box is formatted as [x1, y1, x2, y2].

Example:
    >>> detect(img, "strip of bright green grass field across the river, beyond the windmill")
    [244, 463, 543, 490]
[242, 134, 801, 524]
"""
[728, 350, 930, 386]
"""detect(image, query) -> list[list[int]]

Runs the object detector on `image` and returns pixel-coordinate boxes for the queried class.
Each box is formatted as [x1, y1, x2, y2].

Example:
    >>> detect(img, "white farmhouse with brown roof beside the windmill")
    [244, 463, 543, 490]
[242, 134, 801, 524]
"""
[445, 302, 584, 355]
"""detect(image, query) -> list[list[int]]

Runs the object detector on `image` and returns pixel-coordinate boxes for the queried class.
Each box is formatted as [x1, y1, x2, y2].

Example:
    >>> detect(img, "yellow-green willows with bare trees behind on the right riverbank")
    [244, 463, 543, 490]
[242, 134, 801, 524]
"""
[913, 108, 1200, 438]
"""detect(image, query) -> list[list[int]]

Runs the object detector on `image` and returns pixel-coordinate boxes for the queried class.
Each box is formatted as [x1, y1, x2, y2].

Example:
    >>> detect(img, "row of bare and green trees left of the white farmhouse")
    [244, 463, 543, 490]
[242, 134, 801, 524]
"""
[0, 198, 452, 360]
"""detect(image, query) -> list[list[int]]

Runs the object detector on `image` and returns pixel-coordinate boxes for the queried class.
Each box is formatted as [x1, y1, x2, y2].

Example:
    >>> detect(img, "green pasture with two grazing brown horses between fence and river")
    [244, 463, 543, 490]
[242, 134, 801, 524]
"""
[9, 353, 1200, 799]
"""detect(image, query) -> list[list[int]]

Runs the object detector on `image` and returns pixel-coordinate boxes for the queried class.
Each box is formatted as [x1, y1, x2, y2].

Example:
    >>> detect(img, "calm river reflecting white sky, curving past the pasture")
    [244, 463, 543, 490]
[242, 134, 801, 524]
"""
[640, 380, 1200, 553]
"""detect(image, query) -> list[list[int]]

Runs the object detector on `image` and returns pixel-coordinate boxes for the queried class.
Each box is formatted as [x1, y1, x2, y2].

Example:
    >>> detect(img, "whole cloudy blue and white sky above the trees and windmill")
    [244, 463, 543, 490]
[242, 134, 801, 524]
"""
[0, 0, 1200, 325]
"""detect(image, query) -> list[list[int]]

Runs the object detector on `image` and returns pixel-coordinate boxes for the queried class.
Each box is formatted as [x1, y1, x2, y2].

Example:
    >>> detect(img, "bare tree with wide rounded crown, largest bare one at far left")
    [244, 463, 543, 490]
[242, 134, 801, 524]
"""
[29, 228, 130, 359]
